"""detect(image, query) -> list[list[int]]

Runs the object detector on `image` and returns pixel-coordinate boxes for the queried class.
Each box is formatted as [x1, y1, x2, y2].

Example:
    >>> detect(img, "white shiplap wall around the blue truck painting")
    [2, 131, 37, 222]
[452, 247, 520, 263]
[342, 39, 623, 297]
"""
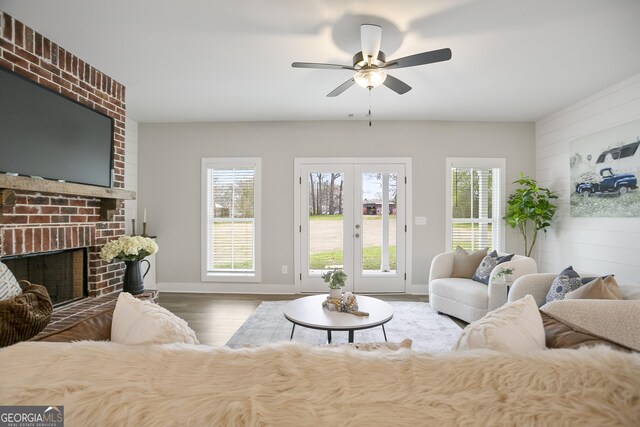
[536, 74, 640, 281]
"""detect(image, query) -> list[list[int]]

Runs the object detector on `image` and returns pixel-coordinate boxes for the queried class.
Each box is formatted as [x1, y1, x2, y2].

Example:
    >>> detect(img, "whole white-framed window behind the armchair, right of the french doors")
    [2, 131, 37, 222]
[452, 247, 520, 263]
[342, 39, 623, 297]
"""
[446, 158, 505, 252]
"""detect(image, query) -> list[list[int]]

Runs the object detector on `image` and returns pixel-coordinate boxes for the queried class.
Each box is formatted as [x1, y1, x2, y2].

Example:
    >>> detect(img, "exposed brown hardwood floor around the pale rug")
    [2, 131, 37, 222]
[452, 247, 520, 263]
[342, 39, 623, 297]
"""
[159, 292, 429, 346]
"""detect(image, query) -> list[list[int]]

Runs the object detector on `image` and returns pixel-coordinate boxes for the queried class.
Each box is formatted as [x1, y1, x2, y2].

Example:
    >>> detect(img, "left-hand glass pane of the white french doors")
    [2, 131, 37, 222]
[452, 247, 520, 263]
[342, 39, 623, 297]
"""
[307, 172, 344, 274]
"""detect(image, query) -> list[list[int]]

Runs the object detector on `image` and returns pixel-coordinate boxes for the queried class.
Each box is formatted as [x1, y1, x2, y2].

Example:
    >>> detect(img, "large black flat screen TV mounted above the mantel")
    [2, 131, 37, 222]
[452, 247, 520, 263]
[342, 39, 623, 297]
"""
[0, 68, 113, 187]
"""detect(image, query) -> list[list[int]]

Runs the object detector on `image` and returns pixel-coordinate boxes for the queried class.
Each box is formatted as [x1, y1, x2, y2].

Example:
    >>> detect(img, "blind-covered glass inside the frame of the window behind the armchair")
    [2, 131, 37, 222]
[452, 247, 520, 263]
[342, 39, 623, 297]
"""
[450, 167, 502, 254]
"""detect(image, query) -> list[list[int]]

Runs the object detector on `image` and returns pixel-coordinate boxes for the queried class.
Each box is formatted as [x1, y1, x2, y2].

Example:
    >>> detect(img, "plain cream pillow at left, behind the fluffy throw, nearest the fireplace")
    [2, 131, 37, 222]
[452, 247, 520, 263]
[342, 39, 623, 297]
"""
[111, 292, 199, 344]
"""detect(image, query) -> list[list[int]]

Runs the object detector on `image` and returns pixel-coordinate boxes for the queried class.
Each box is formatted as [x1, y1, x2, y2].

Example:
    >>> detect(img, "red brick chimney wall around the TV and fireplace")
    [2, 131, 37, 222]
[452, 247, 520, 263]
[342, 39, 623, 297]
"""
[0, 11, 130, 296]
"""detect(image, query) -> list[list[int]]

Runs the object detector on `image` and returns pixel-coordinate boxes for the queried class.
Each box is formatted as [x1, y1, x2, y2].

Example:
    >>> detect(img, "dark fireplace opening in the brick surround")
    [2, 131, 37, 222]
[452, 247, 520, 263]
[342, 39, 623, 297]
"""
[2, 248, 88, 307]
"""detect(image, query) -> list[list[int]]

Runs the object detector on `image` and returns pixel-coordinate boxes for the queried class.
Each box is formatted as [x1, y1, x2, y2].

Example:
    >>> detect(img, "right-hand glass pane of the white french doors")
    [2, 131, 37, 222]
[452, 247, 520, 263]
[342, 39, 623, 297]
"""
[356, 172, 398, 274]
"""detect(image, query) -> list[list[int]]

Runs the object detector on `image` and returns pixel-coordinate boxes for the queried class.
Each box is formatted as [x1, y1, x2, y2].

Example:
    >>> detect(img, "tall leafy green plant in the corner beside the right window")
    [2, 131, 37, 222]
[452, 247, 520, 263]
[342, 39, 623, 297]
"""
[504, 173, 558, 256]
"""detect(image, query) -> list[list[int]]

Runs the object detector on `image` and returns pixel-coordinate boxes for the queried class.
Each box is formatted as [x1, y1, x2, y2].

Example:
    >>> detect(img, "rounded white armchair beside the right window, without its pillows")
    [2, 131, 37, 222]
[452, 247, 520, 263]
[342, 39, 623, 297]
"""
[429, 252, 537, 323]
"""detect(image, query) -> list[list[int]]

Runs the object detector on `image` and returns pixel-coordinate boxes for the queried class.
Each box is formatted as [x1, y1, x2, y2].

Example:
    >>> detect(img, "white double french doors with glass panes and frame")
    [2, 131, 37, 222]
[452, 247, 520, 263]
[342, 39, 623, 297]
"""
[296, 159, 406, 292]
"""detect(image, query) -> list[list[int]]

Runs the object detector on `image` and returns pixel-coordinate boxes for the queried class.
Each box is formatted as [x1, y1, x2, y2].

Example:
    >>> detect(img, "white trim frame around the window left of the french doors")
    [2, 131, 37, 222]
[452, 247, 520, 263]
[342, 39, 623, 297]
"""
[200, 157, 262, 282]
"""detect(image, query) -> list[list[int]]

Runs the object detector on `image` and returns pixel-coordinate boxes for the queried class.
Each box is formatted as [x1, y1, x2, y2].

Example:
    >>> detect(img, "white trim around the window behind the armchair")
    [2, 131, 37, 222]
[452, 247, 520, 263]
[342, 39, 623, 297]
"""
[445, 157, 507, 252]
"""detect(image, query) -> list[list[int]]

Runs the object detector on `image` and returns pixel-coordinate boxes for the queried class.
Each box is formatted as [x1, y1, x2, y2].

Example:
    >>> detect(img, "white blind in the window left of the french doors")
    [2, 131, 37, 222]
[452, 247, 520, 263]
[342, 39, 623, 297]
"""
[207, 167, 256, 273]
